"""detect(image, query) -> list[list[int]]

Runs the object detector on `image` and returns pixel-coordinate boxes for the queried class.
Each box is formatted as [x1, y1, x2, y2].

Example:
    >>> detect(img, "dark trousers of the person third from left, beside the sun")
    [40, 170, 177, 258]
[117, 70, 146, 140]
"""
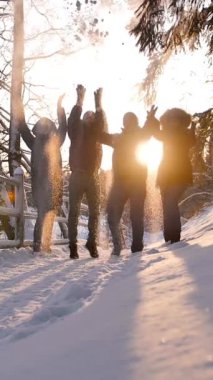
[107, 181, 146, 253]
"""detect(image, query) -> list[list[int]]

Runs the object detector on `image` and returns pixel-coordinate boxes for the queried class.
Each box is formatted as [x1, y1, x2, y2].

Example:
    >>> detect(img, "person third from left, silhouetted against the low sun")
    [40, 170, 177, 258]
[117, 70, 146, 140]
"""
[100, 112, 156, 256]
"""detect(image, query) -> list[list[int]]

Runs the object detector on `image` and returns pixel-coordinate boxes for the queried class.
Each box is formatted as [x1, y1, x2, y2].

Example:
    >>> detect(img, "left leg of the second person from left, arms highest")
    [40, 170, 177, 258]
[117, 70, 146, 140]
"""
[68, 172, 85, 259]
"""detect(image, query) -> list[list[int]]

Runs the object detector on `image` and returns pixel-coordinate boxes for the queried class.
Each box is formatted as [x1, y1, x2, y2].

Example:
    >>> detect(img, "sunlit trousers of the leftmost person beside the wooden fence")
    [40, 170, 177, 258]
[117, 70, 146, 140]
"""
[33, 206, 56, 251]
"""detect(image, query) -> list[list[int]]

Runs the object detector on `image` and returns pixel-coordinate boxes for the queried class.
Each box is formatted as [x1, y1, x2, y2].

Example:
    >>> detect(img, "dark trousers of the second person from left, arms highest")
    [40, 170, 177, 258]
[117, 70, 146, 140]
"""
[68, 171, 100, 246]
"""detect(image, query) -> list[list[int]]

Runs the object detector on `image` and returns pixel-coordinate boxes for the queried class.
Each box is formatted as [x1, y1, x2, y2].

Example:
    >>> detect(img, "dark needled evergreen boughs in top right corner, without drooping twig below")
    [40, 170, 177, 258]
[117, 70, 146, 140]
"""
[131, 0, 213, 54]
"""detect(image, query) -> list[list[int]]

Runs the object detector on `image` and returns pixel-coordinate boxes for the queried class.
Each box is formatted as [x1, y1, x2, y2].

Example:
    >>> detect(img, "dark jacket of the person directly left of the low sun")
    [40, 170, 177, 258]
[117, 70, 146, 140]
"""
[100, 127, 151, 185]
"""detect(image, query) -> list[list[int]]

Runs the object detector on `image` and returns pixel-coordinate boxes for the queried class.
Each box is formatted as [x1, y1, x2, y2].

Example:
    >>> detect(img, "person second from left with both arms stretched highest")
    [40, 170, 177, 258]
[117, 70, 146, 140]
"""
[68, 84, 106, 259]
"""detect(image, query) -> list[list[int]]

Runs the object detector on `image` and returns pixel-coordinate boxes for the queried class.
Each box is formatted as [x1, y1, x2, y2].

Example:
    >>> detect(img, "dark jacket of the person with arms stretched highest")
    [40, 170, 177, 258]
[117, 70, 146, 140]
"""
[68, 105, 107, 174]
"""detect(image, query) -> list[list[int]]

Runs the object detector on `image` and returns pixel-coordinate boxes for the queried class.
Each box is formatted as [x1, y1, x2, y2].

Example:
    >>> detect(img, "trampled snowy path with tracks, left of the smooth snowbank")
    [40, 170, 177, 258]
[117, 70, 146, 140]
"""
[0, 246, 129, 344]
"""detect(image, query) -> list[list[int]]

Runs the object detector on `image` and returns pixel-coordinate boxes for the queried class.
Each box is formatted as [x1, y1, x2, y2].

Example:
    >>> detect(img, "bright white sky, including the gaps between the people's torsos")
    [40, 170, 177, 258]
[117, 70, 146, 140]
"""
[21, 1, 148, 169]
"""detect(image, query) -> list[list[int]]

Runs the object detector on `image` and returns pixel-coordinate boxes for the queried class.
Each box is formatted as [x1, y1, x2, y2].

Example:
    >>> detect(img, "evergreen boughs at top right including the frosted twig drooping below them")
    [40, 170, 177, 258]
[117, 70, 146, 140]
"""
[130, 0, 213, 105]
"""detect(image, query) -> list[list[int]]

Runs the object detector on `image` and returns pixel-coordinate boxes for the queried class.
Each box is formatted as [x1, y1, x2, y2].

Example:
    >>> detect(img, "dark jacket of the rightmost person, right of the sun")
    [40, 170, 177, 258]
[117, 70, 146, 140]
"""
[154, 128, 195, 188]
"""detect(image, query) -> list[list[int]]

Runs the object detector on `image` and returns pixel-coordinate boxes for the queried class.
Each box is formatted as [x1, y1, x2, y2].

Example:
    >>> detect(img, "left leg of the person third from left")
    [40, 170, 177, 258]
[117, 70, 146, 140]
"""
[107, 183, 127, 256]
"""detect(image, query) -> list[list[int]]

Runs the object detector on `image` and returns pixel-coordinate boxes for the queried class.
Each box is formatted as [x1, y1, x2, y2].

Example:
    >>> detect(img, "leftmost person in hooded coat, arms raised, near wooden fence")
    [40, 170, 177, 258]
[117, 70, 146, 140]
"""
[19, 96, 67, 252]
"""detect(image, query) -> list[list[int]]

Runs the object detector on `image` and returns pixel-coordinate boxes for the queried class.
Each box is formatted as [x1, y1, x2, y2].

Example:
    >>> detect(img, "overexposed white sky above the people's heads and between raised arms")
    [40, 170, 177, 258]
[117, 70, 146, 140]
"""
[27, 1, 148, 125]
